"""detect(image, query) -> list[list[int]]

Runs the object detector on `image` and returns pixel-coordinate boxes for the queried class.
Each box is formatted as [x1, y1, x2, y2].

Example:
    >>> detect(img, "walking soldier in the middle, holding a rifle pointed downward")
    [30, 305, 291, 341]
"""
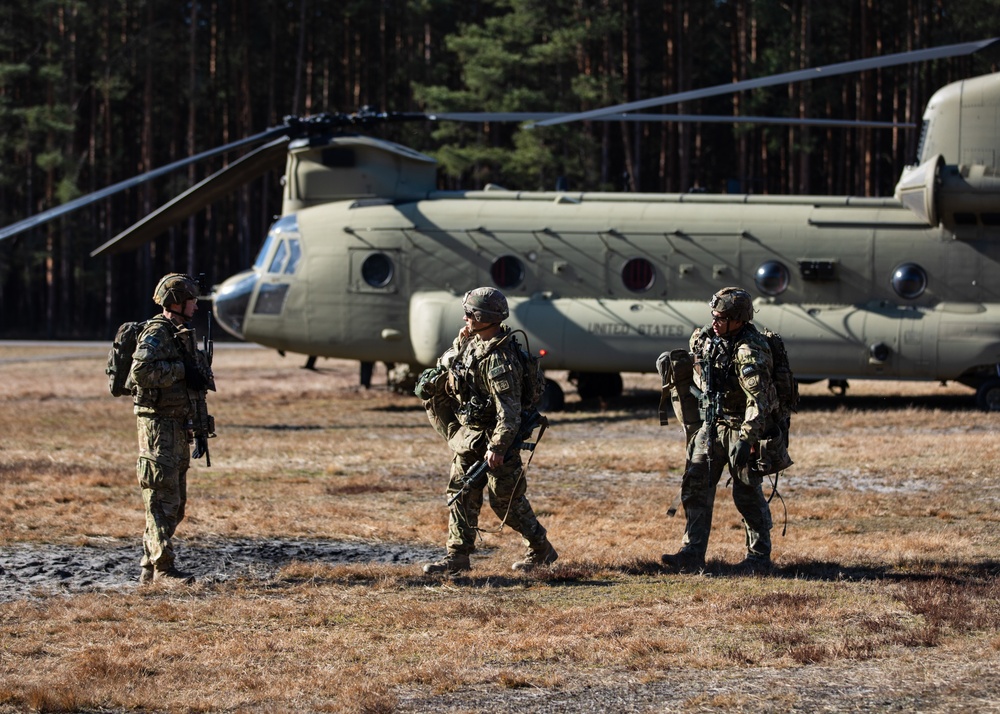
[424, 287, 559, 574]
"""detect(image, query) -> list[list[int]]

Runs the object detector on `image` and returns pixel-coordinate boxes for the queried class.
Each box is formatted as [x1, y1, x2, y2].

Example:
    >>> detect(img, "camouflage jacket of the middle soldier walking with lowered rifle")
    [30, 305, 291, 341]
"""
[449, 325, 522, 454]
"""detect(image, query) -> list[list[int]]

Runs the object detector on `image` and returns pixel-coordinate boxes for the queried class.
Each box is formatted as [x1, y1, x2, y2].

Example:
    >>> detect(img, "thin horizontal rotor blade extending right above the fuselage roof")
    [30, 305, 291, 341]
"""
[427, 112, 916, 129]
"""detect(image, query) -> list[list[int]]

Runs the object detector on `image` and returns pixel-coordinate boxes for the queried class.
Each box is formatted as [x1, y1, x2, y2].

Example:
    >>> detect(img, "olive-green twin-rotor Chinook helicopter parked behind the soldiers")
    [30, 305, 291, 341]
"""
[0, 40, 1000, 410]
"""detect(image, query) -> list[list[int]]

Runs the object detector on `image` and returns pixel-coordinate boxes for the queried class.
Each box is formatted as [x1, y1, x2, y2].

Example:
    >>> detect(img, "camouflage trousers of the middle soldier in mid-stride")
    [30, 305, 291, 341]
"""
[448, 427, 548, 555]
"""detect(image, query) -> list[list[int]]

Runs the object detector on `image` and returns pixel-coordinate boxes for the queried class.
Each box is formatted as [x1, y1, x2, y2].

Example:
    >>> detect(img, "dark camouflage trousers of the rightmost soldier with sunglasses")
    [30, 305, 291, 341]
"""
[681, 424, 771, 561]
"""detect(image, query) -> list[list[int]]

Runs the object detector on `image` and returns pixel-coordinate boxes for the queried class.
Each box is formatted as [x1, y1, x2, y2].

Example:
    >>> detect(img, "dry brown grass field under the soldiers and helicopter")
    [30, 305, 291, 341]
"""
[0, 343, 1000, 713]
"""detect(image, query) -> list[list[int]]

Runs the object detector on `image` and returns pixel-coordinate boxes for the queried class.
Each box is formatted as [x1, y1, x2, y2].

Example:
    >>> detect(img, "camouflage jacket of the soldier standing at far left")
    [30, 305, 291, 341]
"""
[129, 315, 194, 419]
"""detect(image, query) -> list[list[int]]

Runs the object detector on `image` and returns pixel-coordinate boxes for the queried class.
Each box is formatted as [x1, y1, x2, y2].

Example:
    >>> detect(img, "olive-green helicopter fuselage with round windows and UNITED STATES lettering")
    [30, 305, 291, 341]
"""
[216, 184, 1000, 382]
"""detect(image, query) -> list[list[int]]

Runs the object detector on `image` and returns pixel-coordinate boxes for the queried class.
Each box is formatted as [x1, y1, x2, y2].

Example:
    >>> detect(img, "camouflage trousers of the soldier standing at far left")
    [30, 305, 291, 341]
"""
[136, 416, 191, 570]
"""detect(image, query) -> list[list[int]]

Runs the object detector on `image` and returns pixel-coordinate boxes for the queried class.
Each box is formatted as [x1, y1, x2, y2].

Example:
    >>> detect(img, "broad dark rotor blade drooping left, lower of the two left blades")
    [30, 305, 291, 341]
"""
[90, 136, 289, 257]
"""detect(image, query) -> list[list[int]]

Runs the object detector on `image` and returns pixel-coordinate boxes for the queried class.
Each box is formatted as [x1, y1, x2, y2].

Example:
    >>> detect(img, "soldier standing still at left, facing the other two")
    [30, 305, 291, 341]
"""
[127, 273, 215, 584]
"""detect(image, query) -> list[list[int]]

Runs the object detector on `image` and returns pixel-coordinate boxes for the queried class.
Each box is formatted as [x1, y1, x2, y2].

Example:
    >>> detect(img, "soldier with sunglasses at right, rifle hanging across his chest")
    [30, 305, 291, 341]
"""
[662, 287, 779, 573]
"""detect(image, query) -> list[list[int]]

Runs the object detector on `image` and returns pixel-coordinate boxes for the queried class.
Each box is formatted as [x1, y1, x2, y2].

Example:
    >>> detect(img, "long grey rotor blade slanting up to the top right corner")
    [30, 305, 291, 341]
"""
[534, 37, 998, 126]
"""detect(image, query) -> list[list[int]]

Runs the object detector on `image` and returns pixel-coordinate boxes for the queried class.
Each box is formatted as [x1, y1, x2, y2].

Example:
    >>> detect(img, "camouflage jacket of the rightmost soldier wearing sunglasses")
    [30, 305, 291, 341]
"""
[690, 323, 778, 444]
